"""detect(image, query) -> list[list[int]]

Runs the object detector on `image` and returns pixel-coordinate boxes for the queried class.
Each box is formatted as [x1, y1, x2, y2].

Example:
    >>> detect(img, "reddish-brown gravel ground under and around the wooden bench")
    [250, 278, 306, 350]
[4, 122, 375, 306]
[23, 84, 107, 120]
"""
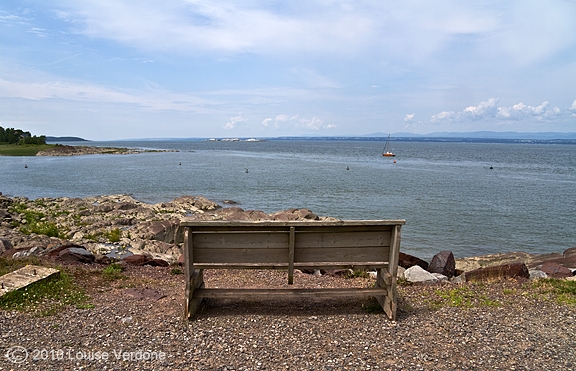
[0, 267, 576, 370]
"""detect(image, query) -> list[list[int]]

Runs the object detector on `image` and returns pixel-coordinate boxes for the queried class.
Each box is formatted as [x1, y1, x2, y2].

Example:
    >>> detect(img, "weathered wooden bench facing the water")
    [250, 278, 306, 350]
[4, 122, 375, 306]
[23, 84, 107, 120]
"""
[181, 220, 405, 320]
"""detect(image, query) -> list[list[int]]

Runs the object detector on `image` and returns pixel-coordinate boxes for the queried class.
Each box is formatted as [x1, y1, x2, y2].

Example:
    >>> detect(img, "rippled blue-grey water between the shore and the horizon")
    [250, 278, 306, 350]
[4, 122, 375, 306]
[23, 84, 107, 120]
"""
[0, 140, 576, 258]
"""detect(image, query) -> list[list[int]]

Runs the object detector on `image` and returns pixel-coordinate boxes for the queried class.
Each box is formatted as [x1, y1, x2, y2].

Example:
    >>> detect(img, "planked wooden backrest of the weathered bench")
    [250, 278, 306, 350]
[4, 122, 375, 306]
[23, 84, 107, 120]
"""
[181, 220, 405, 265]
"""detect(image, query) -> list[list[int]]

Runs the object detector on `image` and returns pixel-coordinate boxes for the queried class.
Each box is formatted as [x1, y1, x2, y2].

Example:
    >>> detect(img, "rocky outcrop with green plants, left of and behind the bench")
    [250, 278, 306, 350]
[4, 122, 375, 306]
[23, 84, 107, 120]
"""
[0, 195, 324, 265]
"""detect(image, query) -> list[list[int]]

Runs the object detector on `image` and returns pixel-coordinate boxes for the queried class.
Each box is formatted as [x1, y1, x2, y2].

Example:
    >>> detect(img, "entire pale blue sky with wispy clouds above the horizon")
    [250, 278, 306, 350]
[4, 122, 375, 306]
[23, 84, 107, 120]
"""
[0, 0, 576, 140]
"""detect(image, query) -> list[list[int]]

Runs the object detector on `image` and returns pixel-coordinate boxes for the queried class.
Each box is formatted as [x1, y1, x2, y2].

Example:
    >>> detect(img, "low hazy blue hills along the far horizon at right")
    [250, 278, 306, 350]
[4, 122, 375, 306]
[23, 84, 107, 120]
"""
[363, 131, 576, 140]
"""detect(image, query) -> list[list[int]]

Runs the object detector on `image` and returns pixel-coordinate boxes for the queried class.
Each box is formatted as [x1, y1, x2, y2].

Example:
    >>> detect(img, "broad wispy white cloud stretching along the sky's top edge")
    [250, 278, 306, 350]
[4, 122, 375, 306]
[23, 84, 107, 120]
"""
[47, 0, 524, 63]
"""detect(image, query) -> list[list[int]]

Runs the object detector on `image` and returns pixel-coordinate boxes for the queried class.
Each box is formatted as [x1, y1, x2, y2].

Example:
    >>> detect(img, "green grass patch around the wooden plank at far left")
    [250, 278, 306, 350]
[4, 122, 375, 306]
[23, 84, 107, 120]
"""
[0, 258, 93, 316]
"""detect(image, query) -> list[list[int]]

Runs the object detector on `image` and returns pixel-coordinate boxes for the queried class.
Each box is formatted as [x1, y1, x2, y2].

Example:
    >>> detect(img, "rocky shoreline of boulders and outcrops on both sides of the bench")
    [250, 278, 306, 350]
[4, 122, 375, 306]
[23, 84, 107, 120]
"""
[0, 194, 576, 282]
